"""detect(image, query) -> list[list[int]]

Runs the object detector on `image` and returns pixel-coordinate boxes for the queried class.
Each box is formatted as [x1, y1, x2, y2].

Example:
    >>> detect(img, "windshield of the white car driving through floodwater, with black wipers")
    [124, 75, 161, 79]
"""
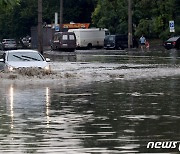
[7, 52, 44, 61]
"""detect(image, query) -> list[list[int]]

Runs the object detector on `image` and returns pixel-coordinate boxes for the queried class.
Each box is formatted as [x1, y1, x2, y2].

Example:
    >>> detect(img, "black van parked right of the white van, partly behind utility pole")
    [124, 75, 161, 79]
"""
[104, 34, 138, 50]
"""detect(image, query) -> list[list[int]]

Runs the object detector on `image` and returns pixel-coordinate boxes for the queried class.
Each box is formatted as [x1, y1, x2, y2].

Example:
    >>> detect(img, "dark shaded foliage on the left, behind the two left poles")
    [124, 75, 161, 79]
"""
[0, 0, 96, 39]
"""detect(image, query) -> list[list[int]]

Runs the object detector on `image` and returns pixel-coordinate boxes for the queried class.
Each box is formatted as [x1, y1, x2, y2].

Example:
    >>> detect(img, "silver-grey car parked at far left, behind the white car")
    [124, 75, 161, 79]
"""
[1, 39, 17, 50]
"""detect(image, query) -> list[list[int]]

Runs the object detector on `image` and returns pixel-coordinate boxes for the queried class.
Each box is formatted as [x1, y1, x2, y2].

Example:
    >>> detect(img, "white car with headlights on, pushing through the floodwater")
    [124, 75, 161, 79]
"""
[0, 50, 50, 72]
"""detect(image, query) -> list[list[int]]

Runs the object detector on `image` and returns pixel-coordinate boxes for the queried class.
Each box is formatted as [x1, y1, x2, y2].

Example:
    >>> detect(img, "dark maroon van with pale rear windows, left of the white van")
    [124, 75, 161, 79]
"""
[51, 32, 76, 51]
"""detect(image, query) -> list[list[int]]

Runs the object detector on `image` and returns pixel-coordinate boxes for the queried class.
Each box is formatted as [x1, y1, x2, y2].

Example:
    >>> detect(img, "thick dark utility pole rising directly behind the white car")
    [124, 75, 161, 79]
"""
[38, 0, 43, 54]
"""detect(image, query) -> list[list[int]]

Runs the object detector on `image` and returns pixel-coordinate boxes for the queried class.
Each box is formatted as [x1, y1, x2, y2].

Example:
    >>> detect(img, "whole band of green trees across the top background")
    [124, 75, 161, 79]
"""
[0, 0, 180, 39]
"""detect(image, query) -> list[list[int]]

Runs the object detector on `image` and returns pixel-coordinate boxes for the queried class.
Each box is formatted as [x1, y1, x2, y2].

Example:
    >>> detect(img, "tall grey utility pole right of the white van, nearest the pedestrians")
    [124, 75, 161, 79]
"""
[128, 0, 132, 49]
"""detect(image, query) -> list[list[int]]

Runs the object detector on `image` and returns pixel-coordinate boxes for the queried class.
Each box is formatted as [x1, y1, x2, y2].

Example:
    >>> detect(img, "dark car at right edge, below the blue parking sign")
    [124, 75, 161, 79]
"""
[164, 36, 180, 50]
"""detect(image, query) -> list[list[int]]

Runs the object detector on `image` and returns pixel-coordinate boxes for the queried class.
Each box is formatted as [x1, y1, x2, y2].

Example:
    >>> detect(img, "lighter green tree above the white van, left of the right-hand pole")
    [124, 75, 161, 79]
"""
[92, 0, 128, 33]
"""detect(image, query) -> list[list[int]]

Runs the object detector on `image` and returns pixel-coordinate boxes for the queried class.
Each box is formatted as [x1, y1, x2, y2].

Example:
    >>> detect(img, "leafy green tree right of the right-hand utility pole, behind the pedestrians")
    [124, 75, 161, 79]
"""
[135, 0, 175, 39]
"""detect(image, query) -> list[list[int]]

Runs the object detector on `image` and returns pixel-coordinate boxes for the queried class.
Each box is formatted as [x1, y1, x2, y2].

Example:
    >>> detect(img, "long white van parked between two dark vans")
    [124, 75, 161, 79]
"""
[68, 28, 108, 49]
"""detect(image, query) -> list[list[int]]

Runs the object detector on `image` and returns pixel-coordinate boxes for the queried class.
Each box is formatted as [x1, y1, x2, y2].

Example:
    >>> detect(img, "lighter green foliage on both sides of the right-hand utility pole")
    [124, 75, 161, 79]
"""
[92, 0, 180, 39]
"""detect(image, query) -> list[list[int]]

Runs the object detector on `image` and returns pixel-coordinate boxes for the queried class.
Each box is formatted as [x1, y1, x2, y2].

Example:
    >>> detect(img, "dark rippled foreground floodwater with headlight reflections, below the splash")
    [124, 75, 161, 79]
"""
[0, 77, 180, 154]
